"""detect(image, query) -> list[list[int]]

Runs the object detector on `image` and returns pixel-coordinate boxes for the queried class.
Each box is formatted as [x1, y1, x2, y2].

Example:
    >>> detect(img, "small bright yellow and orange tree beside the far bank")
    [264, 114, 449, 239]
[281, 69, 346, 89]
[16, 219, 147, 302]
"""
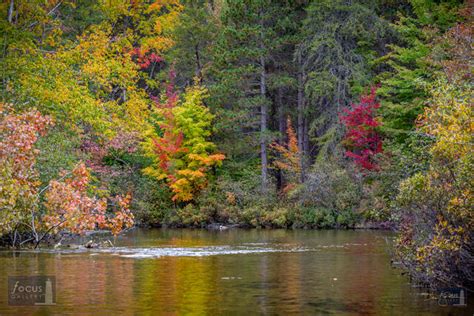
[144, 76, 225, 202]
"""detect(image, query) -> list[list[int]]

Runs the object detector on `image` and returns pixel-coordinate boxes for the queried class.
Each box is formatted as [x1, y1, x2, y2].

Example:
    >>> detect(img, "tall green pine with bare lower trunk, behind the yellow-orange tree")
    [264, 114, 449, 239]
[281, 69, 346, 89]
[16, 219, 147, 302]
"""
[210, 0, 291, 192]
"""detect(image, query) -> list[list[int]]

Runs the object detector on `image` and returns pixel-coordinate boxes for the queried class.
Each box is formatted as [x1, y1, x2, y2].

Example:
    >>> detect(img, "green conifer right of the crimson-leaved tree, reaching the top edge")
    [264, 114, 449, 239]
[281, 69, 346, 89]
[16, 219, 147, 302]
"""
[375, 0, 462, 143]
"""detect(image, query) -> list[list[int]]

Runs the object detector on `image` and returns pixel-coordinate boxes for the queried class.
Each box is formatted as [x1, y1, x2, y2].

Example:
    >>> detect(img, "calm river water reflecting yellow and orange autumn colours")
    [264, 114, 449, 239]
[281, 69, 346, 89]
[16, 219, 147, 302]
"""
[0, 229, 472, 315]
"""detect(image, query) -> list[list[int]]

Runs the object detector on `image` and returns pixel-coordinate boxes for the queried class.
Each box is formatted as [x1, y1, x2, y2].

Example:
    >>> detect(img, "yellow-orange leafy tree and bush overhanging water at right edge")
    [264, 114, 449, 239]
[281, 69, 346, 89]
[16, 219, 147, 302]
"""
[396, 11, 474, 287]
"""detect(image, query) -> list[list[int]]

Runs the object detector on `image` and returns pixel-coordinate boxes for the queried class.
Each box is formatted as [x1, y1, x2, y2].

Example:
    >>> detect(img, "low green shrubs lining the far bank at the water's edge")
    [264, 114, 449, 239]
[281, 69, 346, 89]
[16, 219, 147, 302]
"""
[135, 200, 395, 229]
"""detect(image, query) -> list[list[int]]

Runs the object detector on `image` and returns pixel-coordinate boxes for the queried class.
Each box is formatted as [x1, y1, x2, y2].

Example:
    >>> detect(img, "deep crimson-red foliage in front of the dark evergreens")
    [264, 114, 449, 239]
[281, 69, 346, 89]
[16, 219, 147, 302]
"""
[339, 87, 382, 170]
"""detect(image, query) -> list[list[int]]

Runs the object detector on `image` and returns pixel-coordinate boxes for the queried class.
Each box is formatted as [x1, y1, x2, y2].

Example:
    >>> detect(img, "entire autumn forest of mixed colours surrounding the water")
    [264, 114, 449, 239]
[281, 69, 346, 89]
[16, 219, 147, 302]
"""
[0, 0, 474, 289]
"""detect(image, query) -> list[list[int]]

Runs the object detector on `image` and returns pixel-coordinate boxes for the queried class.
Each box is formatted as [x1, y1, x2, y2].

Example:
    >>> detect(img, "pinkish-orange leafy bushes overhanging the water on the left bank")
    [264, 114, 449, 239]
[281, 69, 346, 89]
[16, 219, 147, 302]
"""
[0, 104, 133, 242]
